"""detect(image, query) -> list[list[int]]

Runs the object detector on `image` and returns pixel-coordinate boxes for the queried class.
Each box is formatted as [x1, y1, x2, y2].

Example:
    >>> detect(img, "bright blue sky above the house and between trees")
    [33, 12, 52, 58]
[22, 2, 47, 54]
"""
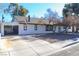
[0, 3, 64, 22]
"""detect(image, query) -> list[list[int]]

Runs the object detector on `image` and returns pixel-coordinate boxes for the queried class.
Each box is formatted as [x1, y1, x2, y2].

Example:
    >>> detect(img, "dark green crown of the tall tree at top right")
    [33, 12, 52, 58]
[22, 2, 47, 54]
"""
[63, 3, 79, 16]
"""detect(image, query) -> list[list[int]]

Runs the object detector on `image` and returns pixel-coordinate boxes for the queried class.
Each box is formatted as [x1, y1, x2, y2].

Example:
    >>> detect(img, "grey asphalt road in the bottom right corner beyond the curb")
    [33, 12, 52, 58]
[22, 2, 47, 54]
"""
[51, 43, 79, 56]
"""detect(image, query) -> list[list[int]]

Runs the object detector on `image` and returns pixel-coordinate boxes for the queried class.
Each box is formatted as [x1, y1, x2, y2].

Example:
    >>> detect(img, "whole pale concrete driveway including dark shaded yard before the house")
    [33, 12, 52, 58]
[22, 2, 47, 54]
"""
[2, 34, 79, 56]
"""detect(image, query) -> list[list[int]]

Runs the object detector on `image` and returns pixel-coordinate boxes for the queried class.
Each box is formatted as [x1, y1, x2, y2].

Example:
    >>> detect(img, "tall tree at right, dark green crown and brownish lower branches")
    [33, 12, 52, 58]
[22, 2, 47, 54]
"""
[63, 3, 79, 32]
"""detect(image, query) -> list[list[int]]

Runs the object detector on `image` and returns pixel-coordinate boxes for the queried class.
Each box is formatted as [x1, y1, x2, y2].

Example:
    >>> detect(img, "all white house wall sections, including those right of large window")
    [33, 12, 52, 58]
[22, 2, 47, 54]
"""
[1, 22, 75, 35]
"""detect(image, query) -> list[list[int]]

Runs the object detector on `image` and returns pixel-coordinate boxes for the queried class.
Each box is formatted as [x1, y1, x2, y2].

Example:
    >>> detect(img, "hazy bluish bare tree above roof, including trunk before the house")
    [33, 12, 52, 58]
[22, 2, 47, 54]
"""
[45, 8, 61, 32]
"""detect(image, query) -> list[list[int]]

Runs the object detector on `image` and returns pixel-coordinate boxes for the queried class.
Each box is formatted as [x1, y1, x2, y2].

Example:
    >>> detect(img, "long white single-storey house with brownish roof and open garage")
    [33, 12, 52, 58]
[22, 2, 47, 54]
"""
[0, 16, 73, 35]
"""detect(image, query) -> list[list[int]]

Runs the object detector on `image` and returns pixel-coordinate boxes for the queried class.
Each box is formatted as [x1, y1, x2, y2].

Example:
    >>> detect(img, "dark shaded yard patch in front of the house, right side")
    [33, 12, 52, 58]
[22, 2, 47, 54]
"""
[29, 33, 79, 43]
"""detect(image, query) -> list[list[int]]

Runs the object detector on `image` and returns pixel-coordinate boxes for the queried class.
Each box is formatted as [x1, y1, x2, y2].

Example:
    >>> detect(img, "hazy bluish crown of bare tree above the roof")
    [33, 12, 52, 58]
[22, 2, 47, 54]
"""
[44, 8, 59, 23]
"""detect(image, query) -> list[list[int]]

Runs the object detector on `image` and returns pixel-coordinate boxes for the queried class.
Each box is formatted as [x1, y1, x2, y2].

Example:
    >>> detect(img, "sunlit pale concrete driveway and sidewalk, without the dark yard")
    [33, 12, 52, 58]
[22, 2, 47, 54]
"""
[0, 36, 79, 56]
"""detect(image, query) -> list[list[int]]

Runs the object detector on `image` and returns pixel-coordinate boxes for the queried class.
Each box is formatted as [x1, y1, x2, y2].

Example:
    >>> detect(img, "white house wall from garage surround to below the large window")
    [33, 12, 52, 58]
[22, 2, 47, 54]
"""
[1, 23, 53, 36]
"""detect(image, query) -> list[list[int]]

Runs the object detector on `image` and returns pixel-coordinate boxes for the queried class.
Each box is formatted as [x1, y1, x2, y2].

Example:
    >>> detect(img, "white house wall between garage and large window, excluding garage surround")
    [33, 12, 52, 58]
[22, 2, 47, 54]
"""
[19, 24, 53, 35]
